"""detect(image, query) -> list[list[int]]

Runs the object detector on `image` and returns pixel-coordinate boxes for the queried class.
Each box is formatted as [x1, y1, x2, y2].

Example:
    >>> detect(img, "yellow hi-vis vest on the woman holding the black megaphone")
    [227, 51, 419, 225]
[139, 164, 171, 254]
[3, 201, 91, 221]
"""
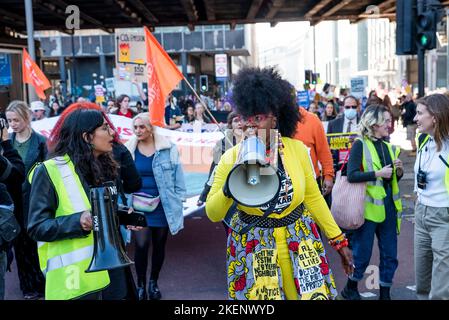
[28, 155, 110, 300]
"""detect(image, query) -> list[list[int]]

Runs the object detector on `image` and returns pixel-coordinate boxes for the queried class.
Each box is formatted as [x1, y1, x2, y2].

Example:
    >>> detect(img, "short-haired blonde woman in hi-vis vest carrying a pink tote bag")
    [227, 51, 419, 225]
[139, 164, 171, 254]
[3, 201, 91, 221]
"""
[341, 105, 403, 300]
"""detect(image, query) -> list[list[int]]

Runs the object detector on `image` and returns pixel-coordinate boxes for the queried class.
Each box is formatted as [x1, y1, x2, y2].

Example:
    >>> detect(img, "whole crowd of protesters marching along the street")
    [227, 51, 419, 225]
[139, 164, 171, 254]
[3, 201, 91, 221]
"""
[0, 35, 449, 300]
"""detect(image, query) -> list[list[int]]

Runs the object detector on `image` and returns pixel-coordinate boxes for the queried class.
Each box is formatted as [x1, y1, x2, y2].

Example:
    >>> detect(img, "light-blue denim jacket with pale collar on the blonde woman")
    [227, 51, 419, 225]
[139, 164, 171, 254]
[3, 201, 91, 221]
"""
[125, 132, 186, 235]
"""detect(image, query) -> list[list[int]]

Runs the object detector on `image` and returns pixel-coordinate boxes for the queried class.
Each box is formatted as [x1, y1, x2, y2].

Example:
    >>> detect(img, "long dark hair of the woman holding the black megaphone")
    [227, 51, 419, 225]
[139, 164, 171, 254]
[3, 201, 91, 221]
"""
[52, 109, 118, 186]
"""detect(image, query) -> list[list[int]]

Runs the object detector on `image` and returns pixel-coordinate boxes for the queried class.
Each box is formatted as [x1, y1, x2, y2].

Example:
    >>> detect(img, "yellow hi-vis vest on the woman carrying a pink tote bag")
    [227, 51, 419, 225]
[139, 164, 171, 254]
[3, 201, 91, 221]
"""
[358, 138, 402, 234]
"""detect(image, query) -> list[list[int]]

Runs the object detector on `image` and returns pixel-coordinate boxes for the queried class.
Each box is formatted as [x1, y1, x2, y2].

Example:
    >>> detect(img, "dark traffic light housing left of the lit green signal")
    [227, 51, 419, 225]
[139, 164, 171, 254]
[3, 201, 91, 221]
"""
[396, 0, 418, 55]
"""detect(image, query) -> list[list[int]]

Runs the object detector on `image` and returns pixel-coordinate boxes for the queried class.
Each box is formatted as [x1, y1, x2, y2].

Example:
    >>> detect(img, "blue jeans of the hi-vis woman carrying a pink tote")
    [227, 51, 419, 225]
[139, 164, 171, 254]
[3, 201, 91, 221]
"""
[350, 188, 398, 287]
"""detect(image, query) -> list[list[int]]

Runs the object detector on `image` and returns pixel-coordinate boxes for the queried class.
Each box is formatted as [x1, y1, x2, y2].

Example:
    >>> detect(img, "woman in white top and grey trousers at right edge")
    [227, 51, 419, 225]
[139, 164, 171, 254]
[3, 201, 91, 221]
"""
[414, 94, 449, 300]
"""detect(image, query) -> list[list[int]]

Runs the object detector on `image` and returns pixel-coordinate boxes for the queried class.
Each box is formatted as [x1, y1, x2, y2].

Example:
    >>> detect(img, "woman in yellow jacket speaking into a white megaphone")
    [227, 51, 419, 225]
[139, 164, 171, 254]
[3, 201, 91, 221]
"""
[206, 68, 353, 300]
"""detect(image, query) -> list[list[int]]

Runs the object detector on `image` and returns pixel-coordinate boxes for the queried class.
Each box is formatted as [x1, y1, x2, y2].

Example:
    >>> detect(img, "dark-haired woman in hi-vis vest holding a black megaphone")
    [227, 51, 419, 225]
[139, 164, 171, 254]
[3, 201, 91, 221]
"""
[28, 109, 136, 300]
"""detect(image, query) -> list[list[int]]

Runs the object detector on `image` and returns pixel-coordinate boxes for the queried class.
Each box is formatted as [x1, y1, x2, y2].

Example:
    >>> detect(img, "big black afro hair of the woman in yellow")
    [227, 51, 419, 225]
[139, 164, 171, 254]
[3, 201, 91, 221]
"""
[232, 67, 301, 138]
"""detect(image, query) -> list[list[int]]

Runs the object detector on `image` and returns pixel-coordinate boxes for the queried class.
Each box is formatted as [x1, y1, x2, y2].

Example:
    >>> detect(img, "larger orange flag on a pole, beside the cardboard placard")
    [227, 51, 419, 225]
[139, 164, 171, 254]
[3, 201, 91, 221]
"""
[144, 27, 184, 127]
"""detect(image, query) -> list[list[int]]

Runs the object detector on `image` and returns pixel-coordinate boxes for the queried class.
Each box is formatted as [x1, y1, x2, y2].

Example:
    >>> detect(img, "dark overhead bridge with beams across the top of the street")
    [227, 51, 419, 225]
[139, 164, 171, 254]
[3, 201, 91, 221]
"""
[0, 0, 396, 33]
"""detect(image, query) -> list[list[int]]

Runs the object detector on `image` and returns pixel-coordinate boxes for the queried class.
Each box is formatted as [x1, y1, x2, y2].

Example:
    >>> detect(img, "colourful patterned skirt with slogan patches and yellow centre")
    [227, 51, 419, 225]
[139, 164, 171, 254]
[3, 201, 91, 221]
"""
[226, 210, 337, 300]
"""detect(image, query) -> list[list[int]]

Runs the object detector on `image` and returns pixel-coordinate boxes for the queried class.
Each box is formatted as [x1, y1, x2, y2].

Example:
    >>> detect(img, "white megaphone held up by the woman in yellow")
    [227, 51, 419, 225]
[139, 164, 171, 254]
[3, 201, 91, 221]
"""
[227, 136, 281, 207]
